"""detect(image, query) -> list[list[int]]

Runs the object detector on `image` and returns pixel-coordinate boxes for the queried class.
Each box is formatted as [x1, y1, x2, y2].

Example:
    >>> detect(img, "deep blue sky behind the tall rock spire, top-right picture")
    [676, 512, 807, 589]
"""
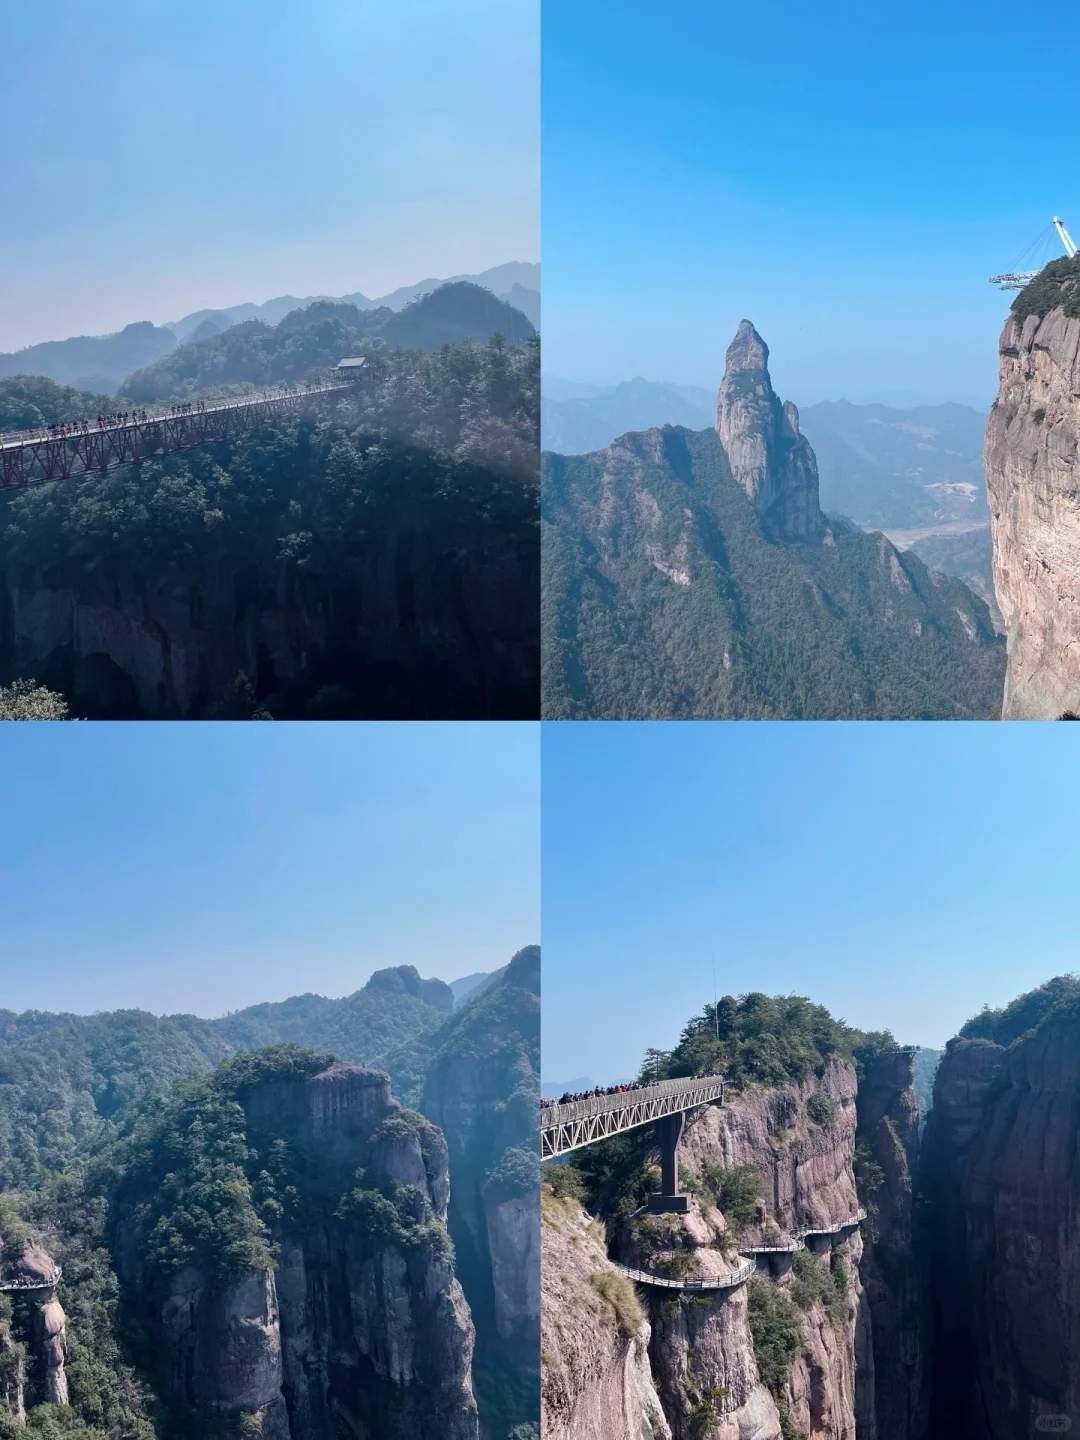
[543, 0, 1080, 405]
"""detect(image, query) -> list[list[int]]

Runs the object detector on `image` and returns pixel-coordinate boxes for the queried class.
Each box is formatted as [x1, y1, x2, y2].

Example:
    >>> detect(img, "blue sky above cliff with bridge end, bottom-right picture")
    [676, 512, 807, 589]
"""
[541, 721, 1080, 1080]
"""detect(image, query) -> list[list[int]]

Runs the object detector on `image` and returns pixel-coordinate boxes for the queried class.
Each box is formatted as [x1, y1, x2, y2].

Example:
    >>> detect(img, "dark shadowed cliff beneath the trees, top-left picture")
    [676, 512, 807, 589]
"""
[0, 517, 540, 720]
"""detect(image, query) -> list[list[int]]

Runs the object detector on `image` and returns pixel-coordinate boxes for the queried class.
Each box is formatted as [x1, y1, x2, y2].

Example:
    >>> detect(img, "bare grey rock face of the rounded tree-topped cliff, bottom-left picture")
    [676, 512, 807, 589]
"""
[128, 1064, 478, 1440]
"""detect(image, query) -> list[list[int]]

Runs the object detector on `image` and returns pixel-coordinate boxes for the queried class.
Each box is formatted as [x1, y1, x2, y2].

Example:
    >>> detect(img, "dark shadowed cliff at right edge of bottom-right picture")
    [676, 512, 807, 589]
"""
[926, 1014, 1080, 1440]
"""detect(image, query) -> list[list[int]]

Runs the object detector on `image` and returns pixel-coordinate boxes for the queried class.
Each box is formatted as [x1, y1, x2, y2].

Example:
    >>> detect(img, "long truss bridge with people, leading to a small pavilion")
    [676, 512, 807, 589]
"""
[0, 380, 356, 490]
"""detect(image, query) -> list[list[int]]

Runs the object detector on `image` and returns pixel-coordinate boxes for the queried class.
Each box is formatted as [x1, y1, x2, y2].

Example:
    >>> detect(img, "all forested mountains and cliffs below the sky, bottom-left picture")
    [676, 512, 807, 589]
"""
[0, 950, 539, 1440]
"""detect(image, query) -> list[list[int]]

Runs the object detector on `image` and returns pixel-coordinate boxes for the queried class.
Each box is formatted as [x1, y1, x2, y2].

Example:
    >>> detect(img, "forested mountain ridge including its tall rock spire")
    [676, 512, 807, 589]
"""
[541, 321, 1004, 719]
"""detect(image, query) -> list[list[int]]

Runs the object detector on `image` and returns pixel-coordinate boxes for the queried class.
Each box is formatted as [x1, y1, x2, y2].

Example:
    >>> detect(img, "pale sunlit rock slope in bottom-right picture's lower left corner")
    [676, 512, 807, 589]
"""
[540, 1189, 671, 1440]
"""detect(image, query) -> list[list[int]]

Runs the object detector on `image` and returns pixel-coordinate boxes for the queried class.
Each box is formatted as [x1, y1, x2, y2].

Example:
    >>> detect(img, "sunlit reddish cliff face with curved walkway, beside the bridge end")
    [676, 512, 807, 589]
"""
[656, 1061, 863, 1440]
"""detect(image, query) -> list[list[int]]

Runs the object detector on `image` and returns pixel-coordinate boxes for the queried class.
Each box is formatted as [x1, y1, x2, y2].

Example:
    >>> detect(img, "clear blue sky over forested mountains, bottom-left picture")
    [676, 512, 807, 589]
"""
[0, 723, 540, 1015]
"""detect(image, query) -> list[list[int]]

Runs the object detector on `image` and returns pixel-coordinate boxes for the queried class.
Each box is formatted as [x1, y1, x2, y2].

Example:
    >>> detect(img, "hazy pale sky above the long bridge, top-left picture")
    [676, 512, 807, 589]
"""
[0, 0, 540, 351]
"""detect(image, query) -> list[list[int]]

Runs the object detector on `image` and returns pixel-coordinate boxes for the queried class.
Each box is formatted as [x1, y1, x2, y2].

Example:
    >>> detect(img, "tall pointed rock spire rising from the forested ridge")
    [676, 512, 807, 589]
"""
[716, 320, 825, 544]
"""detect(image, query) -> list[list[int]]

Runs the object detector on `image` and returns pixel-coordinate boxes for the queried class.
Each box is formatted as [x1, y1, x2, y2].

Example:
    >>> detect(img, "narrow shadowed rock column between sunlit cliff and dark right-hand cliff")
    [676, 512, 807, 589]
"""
[855, 1051, 929, 1440]
